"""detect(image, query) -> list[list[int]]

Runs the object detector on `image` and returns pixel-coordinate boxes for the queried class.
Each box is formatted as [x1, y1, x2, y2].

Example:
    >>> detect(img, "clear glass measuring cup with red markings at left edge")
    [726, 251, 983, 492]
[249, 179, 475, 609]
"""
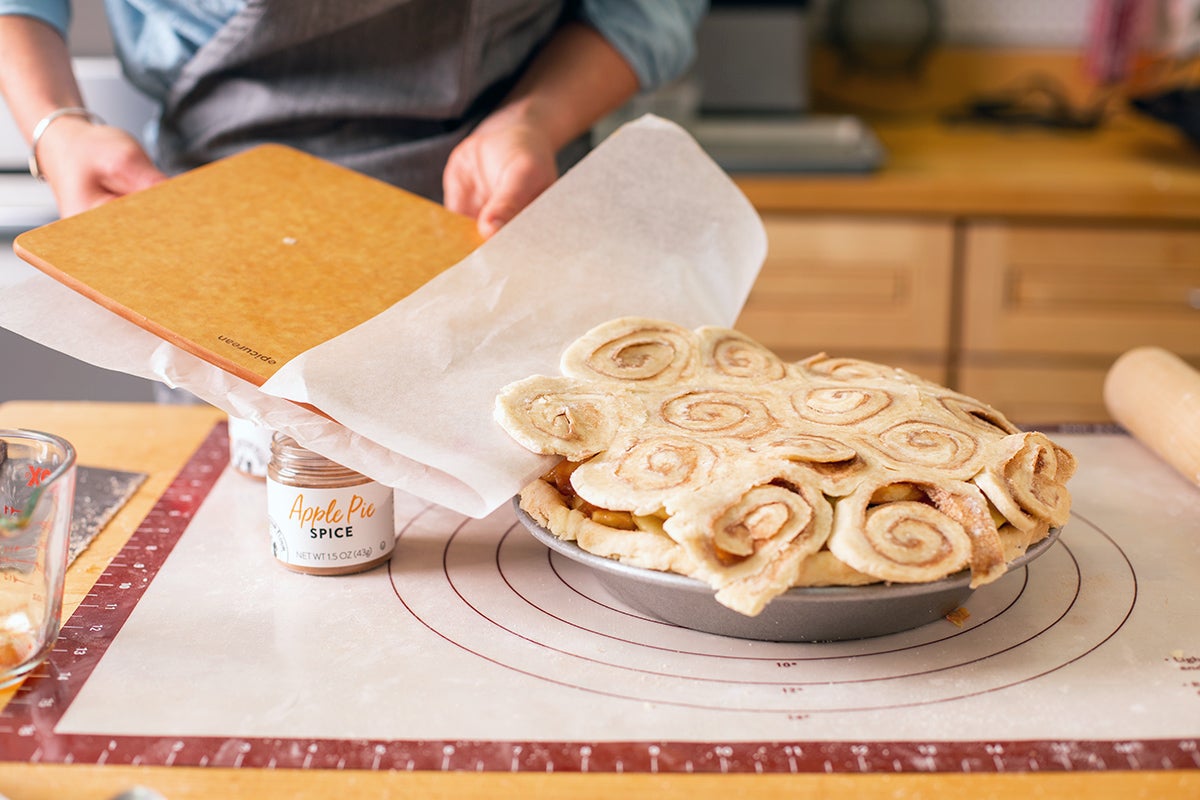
[0, 428, 76, 688]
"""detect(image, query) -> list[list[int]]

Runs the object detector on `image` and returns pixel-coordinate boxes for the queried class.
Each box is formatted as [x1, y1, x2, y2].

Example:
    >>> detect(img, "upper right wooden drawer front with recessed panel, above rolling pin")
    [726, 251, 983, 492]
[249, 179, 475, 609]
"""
[962, 222, 1200, 357]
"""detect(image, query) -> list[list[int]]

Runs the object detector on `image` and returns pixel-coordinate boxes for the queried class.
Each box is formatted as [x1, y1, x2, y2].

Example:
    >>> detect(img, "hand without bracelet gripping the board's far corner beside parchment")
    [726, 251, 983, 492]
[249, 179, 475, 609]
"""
[442, 118, 558, 236]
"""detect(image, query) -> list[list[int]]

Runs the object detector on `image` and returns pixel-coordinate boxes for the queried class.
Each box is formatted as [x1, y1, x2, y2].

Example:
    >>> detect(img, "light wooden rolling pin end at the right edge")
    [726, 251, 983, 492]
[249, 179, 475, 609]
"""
[1104, 347, 1200, 486]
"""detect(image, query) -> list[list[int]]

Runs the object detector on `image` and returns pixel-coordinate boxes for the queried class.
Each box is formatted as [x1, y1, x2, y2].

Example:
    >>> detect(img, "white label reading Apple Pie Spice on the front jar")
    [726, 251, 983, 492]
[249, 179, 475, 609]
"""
[266, 479, 396, 567]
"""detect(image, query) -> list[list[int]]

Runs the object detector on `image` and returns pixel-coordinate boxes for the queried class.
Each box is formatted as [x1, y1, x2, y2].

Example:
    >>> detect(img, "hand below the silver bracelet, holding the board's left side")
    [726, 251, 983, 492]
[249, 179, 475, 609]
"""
[37, 116, 166, 217]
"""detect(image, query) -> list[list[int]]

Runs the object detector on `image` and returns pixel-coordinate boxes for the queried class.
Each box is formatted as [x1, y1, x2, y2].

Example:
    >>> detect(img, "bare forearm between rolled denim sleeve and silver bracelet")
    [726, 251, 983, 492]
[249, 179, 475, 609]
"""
[0, 16, 83, 140]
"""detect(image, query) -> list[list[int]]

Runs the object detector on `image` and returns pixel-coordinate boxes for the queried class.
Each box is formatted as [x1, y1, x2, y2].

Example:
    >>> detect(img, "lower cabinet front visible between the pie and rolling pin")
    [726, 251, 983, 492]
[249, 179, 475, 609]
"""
[958, 366, 1111, 426]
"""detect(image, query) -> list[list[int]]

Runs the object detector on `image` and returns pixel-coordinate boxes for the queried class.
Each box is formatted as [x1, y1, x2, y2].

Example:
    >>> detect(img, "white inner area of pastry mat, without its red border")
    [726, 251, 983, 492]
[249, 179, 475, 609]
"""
[56, 435, 1200, 747]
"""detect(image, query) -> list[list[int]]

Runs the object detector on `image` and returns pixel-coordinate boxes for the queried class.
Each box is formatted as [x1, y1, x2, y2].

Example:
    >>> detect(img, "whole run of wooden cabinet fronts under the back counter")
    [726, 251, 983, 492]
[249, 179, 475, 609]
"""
[738, 212, 1200, 425]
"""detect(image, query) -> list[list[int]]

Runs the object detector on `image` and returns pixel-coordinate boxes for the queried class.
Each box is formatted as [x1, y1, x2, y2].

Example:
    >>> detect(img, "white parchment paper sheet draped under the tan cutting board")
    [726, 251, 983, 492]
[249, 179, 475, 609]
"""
[0, 116, 767, 517]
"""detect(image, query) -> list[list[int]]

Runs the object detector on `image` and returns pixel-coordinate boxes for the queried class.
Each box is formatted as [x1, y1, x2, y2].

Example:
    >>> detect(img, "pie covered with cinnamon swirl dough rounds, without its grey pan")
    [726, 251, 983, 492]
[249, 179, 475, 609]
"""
[496, 317, 1075, 615]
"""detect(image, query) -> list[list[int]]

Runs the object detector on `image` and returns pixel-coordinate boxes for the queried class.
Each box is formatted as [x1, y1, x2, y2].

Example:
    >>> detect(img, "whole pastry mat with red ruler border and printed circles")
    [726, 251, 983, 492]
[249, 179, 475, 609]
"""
[0, 427, 1200, 772]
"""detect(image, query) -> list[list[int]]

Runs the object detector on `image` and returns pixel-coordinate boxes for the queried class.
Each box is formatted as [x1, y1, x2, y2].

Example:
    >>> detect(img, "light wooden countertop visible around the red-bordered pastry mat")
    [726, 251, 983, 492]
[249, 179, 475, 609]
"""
[0, 402, 1200, 800]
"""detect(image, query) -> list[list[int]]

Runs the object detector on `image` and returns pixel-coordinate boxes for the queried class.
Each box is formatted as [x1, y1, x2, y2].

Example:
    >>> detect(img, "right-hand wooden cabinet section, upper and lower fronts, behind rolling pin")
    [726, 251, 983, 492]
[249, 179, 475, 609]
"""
[952, 221, 1200, 422]
